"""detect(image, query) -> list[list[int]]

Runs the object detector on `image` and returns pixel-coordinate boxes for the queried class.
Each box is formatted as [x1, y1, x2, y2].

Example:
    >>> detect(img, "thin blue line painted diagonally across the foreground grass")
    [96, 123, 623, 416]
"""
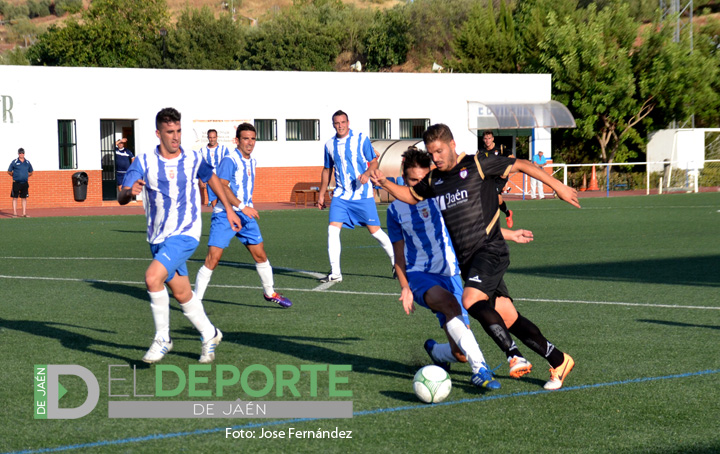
[3, 369, 720, 454]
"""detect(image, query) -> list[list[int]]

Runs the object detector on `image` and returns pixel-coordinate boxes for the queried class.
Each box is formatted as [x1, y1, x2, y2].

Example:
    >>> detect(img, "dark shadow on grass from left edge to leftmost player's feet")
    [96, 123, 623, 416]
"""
[0, 318, 145, 363]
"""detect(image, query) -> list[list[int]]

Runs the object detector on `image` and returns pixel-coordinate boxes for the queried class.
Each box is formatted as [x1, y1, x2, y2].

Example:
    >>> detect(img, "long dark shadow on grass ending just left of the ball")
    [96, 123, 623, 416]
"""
[183, 330, 415, 380]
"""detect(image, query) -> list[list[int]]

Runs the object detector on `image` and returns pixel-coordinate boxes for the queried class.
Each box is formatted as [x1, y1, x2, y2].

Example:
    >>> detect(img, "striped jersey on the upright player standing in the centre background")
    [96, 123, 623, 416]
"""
[325, 129, 376, 200]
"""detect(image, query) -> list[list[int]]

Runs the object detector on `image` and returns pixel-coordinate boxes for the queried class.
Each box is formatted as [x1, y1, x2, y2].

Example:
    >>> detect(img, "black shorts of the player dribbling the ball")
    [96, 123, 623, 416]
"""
[460, 247, 510, 300]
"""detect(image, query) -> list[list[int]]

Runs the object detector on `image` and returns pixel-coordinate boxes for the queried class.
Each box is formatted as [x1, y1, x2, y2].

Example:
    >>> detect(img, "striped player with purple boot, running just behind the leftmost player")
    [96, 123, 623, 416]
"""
[195, 123, 292, 307]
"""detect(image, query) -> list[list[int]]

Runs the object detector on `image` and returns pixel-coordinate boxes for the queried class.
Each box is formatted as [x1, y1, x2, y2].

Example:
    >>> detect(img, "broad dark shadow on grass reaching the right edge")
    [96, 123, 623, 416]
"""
[509, 255, 720, 287]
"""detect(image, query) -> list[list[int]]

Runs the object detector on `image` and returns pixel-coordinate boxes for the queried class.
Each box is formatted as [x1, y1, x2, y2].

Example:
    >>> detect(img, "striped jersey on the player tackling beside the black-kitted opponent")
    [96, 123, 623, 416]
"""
[387, 199, 460, 276]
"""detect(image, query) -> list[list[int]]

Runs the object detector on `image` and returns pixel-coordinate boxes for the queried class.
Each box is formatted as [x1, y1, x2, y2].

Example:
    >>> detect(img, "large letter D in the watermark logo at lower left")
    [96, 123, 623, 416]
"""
[47, 364, 100, 419]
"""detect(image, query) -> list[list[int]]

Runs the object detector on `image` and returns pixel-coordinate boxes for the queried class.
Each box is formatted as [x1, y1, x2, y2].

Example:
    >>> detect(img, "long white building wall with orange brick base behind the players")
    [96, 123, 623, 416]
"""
[0, 66, 551, 207]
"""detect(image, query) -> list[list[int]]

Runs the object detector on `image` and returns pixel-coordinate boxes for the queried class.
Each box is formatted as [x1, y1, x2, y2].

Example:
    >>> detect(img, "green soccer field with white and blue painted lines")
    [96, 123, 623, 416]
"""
[0, 193, 720, 453]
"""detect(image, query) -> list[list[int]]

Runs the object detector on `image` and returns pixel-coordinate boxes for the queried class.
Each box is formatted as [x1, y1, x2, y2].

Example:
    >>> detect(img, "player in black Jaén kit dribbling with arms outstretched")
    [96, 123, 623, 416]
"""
[371, 124, 580, 389]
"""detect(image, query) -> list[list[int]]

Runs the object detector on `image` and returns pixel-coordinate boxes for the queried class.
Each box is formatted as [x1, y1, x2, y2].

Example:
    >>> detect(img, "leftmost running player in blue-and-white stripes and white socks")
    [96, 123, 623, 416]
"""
[118, 107, 240, 363]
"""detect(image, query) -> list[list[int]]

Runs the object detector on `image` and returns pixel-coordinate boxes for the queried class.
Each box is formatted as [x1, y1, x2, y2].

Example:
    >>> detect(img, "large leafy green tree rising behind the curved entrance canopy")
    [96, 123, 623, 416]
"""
[540, 3, 717, 162]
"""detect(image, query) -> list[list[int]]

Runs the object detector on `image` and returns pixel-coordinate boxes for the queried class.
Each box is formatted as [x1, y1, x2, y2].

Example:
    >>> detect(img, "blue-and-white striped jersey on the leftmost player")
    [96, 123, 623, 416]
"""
[123, 146, 213, 244]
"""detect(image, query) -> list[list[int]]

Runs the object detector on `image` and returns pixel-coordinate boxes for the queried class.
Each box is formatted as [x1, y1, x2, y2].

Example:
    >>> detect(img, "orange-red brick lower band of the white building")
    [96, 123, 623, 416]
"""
[0, 166, 322, 209]
